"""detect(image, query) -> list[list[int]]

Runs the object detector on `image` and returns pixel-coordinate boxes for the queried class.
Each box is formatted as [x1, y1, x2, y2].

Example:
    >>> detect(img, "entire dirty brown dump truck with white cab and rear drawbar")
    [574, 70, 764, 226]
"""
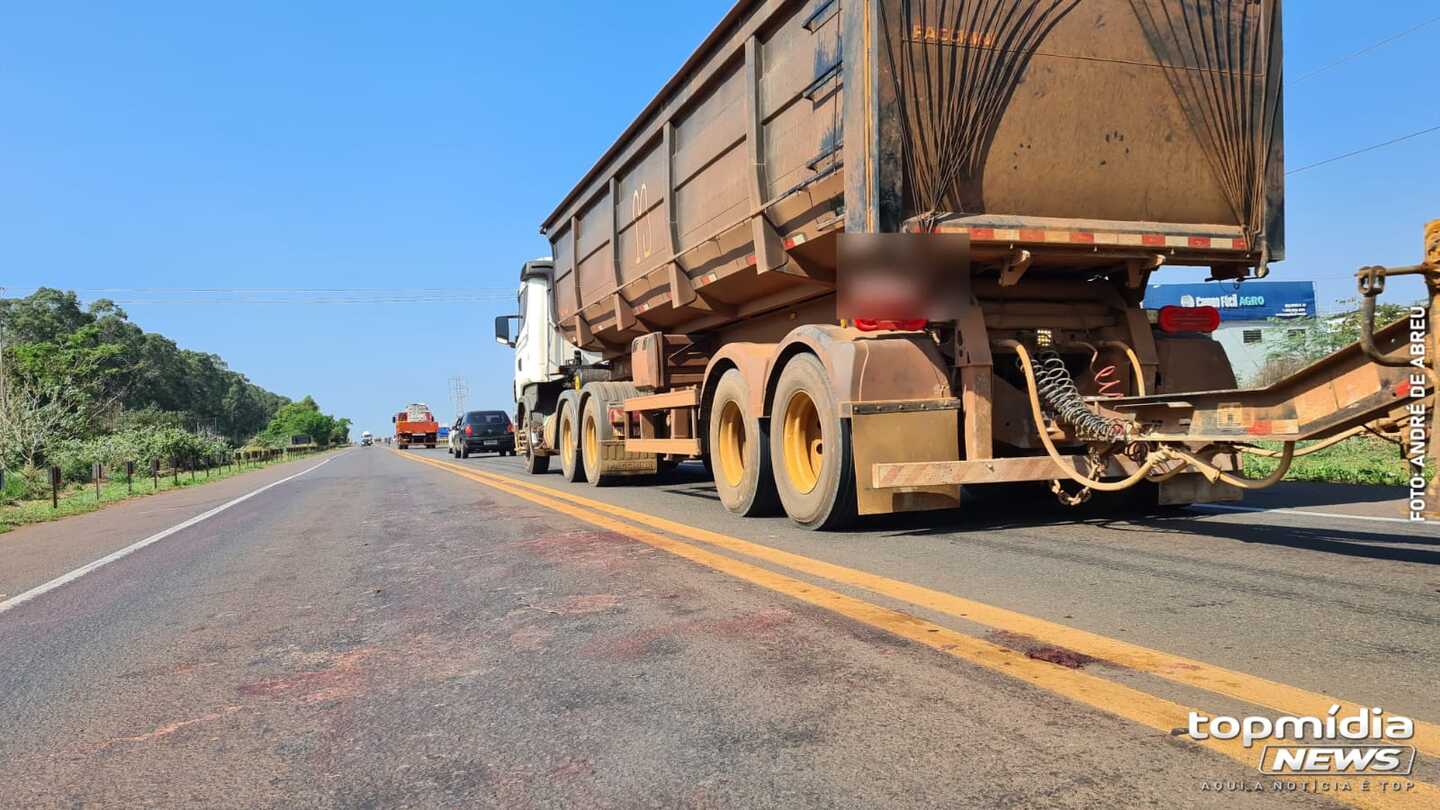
[497, 0, 1436, 528]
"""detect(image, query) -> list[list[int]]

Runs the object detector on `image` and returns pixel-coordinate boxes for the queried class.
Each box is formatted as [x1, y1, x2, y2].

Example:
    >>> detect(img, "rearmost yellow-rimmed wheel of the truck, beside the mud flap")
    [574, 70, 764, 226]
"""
[770, 355, 857, 530]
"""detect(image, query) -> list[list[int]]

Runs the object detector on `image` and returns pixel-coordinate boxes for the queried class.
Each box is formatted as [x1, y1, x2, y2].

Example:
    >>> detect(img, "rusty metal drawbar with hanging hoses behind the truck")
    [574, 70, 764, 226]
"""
[1025, 221, 1440, 520]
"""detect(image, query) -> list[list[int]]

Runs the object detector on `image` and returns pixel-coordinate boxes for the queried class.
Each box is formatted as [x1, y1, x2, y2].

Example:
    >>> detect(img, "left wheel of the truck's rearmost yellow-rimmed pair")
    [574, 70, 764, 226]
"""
[707, 369, 780, 517]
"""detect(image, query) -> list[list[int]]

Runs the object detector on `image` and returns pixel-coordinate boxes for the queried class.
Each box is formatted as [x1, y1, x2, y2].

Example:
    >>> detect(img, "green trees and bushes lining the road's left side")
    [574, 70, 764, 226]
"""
[0, 288, 350, 495]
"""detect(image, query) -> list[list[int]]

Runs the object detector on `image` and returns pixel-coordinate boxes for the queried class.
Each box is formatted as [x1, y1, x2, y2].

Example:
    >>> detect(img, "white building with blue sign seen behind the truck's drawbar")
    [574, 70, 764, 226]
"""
[1145, 281, 1316, 385]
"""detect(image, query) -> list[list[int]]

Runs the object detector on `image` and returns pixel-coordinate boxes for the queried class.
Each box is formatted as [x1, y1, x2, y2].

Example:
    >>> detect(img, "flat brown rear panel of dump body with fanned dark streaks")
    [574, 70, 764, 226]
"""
[873, 0, 1282, 233]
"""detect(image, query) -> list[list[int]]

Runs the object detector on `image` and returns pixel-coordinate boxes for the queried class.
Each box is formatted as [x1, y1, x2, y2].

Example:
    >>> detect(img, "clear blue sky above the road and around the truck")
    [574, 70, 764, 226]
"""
[0, 0, 1440, 435]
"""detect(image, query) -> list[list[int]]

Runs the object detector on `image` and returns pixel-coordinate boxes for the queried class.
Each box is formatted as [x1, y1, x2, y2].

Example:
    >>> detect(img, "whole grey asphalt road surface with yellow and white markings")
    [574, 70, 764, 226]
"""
[0, 448, 1440, 807]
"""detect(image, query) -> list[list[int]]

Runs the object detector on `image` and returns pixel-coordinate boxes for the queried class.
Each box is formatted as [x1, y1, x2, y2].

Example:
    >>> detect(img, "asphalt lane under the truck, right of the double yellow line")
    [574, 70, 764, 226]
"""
[431, 451, 1440, 719]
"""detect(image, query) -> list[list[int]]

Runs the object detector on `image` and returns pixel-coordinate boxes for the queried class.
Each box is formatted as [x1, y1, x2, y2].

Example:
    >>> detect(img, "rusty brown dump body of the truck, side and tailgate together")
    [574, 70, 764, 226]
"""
[543, 0, 1283, 356]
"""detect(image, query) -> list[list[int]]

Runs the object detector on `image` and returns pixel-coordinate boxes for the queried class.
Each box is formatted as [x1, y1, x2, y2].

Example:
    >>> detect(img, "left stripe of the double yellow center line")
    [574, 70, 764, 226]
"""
[402, 454, 1440, 807]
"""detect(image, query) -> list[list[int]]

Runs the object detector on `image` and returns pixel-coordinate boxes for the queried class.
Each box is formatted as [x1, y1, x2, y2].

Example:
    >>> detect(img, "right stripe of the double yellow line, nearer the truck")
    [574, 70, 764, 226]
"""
[403, 458, 1440, 757]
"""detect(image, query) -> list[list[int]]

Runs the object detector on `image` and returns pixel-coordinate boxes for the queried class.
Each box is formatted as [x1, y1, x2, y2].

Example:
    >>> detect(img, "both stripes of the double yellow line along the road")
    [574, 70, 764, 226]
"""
[402, 454, 1440, 807]
